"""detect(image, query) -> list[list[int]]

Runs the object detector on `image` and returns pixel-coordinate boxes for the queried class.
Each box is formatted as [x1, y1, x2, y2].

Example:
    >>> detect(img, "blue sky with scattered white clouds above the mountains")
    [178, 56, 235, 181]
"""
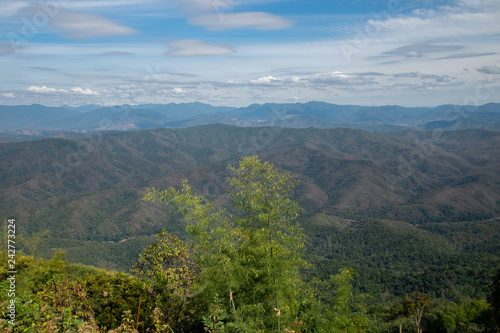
[0, 0, 500, 106]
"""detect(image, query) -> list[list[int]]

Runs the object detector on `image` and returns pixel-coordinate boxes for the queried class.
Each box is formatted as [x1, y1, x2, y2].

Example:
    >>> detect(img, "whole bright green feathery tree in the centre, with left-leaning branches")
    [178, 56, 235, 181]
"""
[145, 157, 307, 332]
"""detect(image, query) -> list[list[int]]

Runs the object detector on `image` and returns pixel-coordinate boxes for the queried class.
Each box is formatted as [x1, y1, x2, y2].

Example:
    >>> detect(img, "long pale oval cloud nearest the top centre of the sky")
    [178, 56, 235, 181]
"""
[189, 12, 293, 30]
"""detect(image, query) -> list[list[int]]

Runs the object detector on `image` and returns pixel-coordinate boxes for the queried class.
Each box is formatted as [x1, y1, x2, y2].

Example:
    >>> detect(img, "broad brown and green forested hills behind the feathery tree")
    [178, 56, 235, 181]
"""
[0, 125, 500, 297]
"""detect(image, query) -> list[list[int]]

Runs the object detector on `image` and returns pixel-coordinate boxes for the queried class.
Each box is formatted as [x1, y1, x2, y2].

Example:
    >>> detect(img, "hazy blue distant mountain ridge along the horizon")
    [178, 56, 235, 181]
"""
[0, 101, 500, 137]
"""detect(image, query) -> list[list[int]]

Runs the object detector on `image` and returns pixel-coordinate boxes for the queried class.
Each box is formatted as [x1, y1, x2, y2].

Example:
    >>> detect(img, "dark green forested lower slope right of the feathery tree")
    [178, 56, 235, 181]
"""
[301, 214, 500, 299]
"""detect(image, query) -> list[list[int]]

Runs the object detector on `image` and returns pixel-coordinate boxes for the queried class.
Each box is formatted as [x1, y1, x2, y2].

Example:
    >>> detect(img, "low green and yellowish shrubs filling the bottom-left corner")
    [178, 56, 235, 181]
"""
[0, 254, 196, 333]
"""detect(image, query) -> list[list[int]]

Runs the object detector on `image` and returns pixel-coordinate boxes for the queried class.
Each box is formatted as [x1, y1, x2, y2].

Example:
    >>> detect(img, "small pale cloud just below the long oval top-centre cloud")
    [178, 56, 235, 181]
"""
[167, 39, 234, 57]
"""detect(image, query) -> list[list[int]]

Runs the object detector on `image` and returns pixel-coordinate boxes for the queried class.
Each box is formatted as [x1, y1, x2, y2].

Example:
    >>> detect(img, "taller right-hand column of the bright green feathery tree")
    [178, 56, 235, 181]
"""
[229, 157, 306, 330]
